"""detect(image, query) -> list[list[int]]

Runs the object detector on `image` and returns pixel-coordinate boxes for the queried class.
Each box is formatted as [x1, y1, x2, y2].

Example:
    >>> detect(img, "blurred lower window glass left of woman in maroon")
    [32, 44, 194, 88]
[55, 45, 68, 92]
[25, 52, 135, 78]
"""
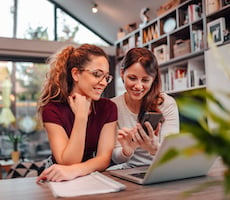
[0, 62, 50, 159]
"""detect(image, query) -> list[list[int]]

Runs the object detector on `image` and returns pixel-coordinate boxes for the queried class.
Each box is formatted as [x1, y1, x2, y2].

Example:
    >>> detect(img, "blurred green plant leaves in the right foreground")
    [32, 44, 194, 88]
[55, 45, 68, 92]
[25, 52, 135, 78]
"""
[177, 37, 230, 193]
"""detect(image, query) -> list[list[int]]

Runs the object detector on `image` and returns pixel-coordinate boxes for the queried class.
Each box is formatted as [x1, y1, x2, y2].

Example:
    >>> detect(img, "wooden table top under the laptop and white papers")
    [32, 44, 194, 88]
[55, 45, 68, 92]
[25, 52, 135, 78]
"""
[0, 159, 229, 200]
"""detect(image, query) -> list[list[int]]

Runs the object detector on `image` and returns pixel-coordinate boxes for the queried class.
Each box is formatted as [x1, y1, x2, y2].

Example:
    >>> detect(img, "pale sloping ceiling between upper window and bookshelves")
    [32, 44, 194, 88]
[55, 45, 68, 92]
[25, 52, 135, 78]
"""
[51, 0, 166, 44]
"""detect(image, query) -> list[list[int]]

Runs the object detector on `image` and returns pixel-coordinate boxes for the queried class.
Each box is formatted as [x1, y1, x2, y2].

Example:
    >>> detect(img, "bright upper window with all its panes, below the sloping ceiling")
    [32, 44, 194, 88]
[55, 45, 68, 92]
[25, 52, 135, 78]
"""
[0, 0, 109, 46]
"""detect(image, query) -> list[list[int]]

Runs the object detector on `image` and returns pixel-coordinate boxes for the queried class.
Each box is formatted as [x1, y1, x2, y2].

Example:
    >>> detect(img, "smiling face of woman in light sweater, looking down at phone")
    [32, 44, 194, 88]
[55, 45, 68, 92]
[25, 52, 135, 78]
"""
[121, 63, 154, 102]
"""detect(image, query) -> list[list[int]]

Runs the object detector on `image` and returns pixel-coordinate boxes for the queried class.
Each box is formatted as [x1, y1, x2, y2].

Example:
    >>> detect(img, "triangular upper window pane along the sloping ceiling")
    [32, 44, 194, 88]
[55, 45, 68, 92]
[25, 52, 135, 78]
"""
[57, 9, 109, 46]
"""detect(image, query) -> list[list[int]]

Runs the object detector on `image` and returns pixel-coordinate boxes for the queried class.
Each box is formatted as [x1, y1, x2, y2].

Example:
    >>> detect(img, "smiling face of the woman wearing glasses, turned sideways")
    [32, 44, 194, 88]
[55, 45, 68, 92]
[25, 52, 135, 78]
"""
[72, 56, 109, 100]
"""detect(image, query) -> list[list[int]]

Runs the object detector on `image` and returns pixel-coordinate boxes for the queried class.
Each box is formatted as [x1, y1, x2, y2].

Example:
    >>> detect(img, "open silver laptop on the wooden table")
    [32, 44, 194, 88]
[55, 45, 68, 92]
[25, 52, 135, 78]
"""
[109, 133, 218, 185]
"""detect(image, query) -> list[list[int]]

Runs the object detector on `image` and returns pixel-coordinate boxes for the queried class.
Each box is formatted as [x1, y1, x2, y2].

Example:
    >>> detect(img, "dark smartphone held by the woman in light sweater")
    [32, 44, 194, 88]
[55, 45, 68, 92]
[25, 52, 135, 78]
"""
[141, 112, 163, 134]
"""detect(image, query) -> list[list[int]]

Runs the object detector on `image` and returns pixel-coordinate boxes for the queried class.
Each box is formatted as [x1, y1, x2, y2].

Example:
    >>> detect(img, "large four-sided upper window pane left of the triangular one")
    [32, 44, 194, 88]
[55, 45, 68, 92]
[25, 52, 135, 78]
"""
[17, 0, 54, 41]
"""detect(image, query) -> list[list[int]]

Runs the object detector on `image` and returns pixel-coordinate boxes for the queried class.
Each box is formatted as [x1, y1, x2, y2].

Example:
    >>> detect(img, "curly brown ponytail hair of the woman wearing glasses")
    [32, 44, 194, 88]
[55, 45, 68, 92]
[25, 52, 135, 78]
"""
[38, 44, 108, 113]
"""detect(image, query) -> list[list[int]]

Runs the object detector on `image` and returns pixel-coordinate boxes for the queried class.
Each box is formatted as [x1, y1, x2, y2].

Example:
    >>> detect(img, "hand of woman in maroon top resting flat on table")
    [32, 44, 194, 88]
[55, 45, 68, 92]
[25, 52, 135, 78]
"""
[37, 164, 77, 183]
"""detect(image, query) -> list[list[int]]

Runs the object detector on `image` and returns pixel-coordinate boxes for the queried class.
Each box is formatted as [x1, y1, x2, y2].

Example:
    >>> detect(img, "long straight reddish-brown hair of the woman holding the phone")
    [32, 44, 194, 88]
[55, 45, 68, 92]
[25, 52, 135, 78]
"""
[121, 48, 164, 121]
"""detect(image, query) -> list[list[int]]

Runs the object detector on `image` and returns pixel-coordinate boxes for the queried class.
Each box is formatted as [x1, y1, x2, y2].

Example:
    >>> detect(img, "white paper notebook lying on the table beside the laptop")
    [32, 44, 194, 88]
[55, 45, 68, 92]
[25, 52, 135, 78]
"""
[49, 172, 126, 197]
